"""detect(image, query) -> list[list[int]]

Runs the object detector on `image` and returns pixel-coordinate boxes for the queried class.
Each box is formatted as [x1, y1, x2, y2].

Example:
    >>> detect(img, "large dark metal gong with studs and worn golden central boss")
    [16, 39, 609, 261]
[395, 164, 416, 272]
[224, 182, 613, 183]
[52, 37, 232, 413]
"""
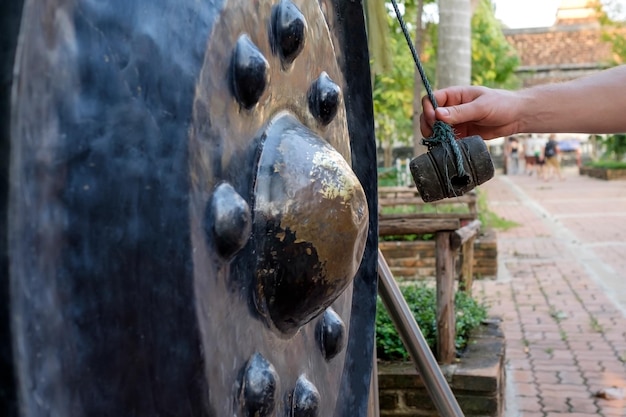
[0, 0, 377, 417]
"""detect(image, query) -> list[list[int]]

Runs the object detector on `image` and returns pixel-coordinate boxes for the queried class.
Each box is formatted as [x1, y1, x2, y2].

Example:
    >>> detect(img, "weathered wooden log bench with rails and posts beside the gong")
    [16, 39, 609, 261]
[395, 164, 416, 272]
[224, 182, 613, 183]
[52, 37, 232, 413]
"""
[378, 187, 481, 364]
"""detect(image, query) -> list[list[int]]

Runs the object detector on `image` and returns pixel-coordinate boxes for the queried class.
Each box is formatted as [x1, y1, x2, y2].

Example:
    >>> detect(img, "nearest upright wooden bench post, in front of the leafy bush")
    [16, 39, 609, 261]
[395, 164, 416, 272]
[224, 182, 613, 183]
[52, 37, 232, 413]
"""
[435, 231, 456, 364]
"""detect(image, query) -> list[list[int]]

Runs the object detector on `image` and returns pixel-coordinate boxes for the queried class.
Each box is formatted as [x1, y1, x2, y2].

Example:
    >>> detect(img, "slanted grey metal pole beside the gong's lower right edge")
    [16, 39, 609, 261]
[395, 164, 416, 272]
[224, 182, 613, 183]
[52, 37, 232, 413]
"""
[378, 250, 463, 417]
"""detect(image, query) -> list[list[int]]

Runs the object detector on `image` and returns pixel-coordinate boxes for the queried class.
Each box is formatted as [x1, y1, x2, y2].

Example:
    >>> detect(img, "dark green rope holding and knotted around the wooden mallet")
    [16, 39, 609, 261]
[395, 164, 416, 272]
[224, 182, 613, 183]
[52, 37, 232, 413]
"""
[391, 0, 467, 181]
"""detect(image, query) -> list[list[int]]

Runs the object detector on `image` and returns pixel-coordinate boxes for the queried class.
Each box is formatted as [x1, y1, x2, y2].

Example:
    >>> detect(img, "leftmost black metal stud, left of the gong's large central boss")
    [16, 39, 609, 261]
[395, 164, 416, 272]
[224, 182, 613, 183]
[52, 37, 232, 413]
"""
[205, 183, 252, 258]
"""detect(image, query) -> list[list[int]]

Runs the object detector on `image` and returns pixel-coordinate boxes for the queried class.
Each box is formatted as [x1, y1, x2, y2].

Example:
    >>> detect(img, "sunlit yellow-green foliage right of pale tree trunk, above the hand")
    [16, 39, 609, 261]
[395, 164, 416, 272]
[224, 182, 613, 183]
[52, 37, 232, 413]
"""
[472, 0, 519, 88]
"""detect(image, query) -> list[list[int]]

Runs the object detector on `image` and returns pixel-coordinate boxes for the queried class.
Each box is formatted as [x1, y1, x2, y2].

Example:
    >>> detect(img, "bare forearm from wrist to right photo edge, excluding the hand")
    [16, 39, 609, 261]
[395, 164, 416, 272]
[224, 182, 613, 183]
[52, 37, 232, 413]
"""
[519, 66, 626, 133]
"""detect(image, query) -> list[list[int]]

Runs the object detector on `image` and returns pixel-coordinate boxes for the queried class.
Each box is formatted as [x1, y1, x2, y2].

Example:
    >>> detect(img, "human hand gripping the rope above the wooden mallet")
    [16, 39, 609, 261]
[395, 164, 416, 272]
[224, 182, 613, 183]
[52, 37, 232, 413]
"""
[420, 86, 523, 139]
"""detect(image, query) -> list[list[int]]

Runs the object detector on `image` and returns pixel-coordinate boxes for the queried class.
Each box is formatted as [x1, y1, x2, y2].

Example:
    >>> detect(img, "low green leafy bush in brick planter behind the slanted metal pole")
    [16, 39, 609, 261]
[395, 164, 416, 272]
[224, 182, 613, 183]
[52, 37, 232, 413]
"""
[376, 284, 487, 360]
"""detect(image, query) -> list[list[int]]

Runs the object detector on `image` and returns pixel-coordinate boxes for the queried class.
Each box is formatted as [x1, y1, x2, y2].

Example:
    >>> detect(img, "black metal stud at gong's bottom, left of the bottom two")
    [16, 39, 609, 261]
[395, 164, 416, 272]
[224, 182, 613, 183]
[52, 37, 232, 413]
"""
[240, 353, 278, 417]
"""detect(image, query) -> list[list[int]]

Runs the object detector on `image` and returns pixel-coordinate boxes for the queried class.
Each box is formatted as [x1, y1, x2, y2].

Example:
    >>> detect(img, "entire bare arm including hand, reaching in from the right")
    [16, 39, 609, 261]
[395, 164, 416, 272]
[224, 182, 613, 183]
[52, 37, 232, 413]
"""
[420, 65, 626, 139]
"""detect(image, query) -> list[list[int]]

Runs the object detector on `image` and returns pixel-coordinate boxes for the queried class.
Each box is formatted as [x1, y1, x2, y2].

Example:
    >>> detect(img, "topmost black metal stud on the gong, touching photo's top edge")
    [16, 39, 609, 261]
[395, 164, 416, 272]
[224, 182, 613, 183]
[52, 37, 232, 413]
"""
[271, 0, 307, 66]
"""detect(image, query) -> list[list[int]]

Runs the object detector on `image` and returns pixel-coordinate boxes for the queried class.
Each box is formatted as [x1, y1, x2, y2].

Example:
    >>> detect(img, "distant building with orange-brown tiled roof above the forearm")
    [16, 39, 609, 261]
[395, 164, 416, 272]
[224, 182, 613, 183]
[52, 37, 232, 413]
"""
[504, 0, 612, 87]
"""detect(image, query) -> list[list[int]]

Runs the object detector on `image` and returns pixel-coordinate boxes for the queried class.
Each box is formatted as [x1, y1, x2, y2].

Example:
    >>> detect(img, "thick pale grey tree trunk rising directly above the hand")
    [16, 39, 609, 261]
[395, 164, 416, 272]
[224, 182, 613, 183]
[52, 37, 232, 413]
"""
[437, 0, 472, 88]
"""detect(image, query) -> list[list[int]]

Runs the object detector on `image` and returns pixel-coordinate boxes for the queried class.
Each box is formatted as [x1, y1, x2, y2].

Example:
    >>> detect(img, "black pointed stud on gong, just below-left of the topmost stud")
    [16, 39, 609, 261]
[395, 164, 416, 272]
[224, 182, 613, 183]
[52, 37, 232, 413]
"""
[231, 34, 269, 109]
